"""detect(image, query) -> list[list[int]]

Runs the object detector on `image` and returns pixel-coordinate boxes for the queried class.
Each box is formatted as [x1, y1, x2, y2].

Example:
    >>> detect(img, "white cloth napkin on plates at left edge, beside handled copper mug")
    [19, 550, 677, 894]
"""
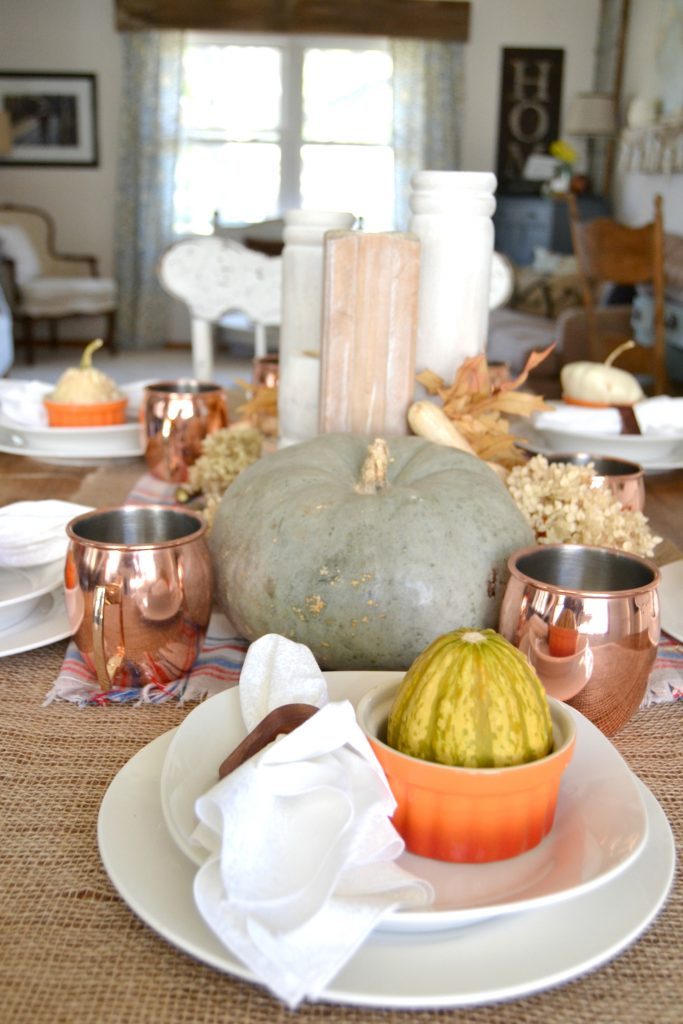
[0, 499, 91, 567]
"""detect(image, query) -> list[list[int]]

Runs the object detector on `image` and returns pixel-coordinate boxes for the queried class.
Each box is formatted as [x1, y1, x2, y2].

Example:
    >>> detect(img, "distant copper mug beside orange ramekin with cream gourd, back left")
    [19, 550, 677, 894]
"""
[140, 380, 228, 483]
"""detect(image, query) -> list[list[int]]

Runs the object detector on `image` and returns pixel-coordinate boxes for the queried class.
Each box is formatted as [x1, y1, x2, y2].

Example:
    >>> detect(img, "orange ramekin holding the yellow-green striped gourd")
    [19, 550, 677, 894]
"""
[356, 683, 577, 863]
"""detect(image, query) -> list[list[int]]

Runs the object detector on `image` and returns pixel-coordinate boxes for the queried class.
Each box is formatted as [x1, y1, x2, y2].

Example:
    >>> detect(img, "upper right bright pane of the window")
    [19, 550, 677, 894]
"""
[303, 49, 392, 145]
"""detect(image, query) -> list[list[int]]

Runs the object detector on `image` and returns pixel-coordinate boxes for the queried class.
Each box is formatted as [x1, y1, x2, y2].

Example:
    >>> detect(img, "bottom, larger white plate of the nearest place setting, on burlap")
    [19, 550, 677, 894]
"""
[97, 733, 675, 1009]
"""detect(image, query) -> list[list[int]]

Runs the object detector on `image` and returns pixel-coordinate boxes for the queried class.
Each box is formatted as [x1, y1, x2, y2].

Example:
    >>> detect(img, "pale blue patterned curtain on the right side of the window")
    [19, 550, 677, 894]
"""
[391, 39, 465, 230]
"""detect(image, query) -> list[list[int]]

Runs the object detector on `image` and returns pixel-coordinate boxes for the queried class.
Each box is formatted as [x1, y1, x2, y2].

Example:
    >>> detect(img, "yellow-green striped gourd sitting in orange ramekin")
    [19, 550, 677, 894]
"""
[387, 629, 553, 768]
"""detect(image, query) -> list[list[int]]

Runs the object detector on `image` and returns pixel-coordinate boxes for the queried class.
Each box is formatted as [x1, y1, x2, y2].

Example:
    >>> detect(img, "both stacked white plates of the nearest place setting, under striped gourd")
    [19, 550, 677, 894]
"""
[98, 672, 675, 1008]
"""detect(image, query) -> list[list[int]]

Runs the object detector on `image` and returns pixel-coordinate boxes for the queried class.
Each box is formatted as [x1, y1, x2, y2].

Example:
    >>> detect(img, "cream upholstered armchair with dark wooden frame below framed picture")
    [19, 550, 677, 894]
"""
[0, 203, 117, 364]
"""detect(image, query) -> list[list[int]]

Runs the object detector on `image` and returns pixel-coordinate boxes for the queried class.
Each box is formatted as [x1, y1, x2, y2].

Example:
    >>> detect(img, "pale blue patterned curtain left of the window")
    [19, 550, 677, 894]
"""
[116, 32, 183, 348]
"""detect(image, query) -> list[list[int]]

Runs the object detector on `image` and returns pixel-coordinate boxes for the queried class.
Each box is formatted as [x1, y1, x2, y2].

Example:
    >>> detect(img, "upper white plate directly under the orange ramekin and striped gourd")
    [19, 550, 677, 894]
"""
[160, 672, 647, 932]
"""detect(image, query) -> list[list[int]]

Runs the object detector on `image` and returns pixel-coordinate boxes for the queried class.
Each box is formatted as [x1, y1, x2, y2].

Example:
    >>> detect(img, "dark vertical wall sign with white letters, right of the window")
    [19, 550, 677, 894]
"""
[496, 48, 564, 193]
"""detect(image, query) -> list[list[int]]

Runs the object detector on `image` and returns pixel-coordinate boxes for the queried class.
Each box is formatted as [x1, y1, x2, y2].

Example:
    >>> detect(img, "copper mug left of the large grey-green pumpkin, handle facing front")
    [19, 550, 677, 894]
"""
[65, 505, 212, 690]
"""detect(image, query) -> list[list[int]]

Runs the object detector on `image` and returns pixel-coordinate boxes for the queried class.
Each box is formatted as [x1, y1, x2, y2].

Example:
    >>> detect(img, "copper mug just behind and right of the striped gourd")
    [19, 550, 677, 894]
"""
[499, 544, 660, 735]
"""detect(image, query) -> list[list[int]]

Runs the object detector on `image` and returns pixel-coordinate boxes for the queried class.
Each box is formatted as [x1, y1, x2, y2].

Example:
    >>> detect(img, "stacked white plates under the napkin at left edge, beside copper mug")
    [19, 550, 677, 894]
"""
[0, 558, 71, 657]
